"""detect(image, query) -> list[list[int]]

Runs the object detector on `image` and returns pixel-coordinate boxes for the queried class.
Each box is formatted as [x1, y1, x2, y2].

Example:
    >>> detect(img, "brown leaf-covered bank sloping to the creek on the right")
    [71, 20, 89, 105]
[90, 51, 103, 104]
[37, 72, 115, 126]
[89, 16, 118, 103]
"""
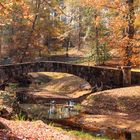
[65, 86, 140, 133]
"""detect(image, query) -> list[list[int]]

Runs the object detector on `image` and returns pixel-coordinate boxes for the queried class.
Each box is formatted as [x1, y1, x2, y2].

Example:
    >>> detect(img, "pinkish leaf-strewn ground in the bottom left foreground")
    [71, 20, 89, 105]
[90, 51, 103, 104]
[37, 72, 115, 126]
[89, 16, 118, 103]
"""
[0, 118, 80, 140]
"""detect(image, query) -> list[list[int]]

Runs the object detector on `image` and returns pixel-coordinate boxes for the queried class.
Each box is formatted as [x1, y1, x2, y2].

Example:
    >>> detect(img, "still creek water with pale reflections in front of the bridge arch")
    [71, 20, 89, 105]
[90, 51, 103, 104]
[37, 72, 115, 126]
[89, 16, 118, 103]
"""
[20, 100, 79, 120]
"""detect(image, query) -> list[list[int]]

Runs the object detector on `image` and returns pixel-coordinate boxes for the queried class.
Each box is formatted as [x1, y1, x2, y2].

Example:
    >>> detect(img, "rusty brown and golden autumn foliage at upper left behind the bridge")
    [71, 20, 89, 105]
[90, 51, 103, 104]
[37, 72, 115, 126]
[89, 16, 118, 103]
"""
[0, 0, 64, 62]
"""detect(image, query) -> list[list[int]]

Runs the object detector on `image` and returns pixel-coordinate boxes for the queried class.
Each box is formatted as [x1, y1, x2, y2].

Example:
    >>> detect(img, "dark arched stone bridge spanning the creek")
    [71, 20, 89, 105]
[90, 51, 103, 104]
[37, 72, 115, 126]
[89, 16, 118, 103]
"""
[0, 61, 131, 88]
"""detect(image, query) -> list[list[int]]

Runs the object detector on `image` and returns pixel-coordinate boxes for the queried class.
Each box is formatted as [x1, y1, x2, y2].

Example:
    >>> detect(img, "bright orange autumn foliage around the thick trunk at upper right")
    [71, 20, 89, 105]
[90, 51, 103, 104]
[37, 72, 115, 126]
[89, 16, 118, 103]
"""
[83, 0, 140, 65]
